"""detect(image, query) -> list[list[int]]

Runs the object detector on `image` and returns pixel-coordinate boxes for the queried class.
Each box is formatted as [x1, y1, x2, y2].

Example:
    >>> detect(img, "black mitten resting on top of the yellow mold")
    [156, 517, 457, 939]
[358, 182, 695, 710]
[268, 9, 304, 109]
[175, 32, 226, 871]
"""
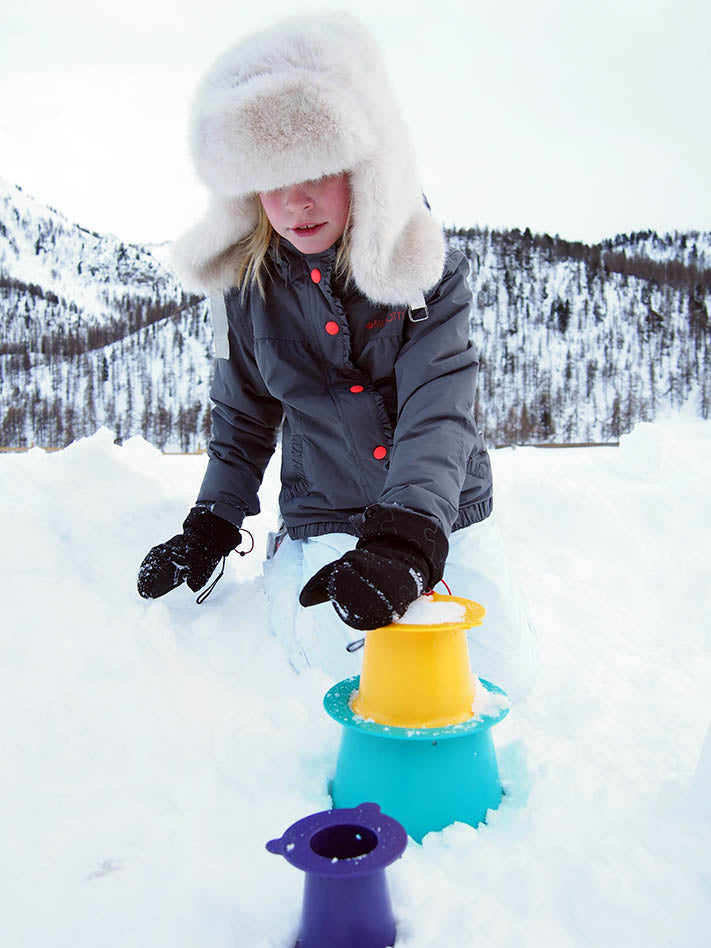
[299, 506, 449, 630]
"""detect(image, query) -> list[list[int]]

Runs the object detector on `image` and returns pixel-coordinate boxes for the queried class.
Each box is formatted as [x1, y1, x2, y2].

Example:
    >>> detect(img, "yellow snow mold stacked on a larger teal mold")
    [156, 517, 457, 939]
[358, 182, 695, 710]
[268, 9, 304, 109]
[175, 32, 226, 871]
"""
[324, 593, 509, 842]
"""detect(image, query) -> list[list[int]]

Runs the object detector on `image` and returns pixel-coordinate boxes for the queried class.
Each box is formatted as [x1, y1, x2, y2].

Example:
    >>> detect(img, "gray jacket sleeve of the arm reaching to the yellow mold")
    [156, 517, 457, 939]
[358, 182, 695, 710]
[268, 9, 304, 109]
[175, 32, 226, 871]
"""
[378, 253, 479, 535]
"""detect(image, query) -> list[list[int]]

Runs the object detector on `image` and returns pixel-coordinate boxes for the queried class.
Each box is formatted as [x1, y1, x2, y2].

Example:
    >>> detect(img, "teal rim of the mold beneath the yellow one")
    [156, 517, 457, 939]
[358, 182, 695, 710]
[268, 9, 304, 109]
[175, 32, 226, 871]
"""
[323, 675, 510, 741]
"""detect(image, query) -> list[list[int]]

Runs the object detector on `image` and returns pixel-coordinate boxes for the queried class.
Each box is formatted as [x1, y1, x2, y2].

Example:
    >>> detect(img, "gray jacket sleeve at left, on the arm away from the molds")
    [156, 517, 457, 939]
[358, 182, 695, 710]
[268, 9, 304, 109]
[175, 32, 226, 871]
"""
[197, 292, 283, 527]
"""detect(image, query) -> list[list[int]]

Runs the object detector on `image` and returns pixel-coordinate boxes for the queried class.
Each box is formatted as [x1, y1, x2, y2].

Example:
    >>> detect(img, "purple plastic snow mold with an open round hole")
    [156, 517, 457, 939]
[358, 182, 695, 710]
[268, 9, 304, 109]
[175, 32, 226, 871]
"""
[267, 803, 407, 948]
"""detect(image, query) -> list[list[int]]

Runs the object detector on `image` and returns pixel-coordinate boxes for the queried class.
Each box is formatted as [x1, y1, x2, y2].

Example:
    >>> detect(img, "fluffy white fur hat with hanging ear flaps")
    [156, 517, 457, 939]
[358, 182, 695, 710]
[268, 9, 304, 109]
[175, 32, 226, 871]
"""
[172, 13, 444, 307]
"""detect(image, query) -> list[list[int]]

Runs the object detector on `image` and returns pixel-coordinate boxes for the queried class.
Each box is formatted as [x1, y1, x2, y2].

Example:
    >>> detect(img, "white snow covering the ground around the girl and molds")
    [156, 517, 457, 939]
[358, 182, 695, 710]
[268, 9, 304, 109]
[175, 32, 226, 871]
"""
[0, 415, 711, 948]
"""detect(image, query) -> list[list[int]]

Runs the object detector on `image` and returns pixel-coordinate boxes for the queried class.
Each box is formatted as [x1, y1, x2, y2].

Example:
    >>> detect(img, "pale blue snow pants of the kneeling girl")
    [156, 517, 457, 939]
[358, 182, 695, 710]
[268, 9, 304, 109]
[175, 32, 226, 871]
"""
[264, 515, 538, 701]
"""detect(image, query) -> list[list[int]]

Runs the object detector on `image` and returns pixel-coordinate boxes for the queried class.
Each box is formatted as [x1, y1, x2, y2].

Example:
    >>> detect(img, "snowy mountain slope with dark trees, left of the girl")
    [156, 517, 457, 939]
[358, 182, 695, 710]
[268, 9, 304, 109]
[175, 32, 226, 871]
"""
[0, 182, 212, 450]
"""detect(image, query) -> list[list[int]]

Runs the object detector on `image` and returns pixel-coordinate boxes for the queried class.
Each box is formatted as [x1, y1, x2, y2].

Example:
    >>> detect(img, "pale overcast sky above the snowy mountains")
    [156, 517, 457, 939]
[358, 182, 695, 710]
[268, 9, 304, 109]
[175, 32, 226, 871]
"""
[0, 0, 711, 241]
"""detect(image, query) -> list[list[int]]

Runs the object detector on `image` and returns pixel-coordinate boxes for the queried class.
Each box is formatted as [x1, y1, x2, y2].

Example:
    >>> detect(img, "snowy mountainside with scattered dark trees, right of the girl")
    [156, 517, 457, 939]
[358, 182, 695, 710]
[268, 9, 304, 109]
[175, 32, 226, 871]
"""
[449, 229, 711, 443]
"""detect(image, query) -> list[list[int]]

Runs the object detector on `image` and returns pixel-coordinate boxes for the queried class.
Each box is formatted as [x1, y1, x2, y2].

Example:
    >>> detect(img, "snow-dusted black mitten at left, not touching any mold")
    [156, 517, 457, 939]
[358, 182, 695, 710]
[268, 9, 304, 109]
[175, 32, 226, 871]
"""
[138, 507, 241, 599]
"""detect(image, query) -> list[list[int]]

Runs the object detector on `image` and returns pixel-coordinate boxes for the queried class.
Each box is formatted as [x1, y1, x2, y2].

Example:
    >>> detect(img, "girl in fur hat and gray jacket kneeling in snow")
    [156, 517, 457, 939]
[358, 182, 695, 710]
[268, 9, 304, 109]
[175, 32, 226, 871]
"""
[138, 14, 535, 697]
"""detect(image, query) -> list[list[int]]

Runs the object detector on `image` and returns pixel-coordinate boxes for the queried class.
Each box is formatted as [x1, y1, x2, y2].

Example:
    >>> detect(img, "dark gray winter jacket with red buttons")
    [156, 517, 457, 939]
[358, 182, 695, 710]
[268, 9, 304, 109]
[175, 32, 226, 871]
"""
[198, 240, 492, 538]
